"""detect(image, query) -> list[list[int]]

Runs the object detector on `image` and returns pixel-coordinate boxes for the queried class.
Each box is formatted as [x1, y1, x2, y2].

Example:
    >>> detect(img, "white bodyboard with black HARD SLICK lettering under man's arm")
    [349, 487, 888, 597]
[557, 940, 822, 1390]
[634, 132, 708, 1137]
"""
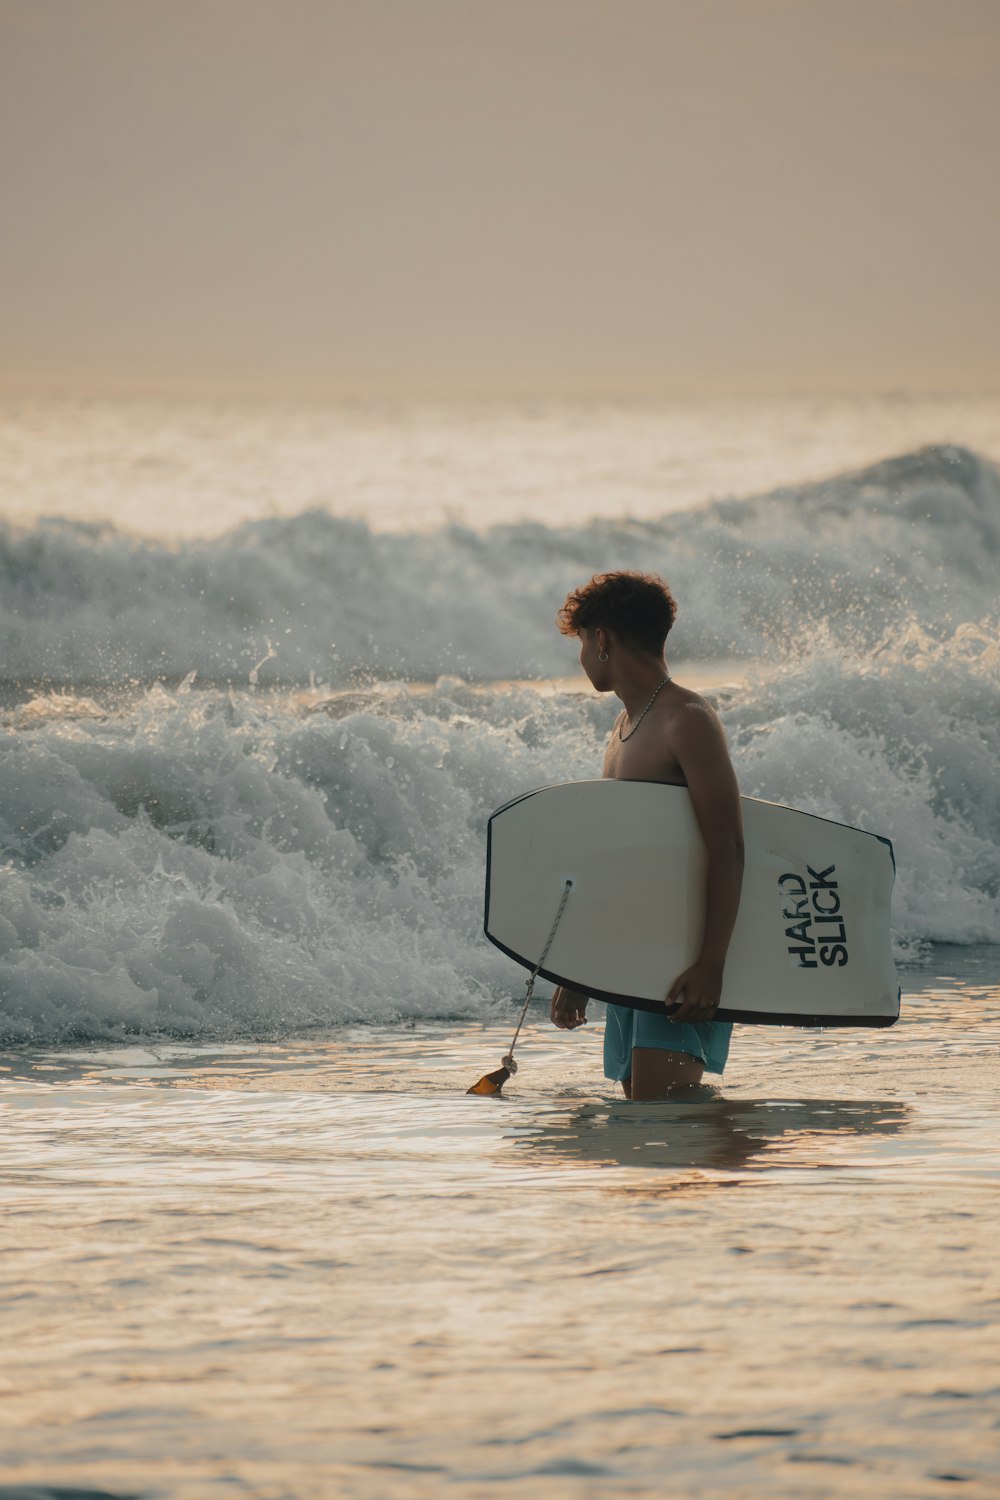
[484, 779, 900, 1026]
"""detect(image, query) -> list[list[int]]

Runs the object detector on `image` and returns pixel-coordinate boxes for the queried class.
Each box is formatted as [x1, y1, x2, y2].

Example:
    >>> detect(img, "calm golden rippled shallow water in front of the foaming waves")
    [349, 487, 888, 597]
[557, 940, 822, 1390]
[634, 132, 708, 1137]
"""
[0, 948, 1000, 1500]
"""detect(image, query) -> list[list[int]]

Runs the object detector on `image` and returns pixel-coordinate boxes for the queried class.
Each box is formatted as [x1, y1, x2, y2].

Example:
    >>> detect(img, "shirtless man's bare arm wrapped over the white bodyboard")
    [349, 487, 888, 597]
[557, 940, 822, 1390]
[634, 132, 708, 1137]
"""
[667, 704, 744, 1025]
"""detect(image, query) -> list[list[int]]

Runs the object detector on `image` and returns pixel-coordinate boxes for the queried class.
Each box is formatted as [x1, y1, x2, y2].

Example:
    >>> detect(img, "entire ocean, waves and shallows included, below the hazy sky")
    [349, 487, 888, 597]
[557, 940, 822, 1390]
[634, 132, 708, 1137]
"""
[0, 402, 1000, 1500]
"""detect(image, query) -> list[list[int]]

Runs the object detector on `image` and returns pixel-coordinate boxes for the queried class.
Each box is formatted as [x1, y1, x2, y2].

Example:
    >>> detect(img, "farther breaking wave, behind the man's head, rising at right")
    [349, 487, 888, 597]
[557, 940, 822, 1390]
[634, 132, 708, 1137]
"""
[0, 447, 1000, 686]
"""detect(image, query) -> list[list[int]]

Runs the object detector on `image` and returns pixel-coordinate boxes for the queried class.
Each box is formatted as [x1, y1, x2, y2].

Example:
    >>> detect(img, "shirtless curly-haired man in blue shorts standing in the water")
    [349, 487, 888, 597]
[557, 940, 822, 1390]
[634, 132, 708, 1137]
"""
[552, 573, 744, 1100]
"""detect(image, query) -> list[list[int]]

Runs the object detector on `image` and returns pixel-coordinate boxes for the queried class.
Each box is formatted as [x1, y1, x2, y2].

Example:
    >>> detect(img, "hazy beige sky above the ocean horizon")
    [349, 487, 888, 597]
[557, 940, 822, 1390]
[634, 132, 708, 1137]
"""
[0, 0, 1000, 396]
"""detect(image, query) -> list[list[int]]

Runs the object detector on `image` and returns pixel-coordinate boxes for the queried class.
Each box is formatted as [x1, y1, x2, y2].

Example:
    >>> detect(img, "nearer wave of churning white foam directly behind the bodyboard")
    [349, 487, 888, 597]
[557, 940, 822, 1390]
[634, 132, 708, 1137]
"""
[0, 609, 1000, 1043]
